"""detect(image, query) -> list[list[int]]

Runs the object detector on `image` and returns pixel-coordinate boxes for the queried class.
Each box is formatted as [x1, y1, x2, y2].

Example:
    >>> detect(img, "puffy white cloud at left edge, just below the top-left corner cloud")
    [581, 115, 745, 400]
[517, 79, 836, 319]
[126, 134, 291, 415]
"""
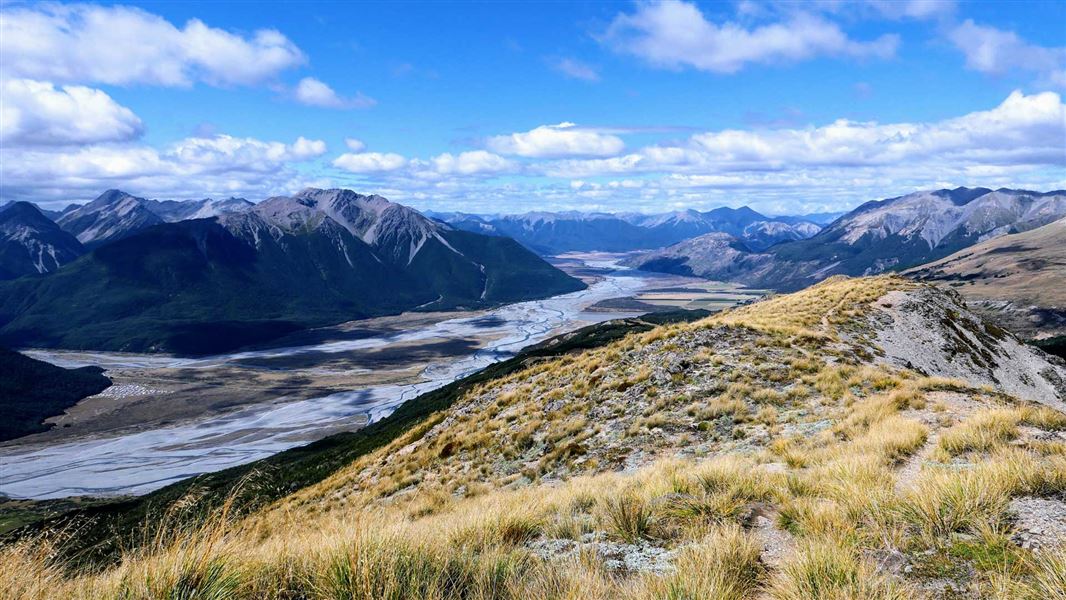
[0, 79, 144, 147]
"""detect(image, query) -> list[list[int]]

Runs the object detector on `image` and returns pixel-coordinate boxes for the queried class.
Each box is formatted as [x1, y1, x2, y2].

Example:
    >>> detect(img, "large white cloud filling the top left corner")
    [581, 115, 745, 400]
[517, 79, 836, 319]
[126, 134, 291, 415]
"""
[0, 3, 305, 86]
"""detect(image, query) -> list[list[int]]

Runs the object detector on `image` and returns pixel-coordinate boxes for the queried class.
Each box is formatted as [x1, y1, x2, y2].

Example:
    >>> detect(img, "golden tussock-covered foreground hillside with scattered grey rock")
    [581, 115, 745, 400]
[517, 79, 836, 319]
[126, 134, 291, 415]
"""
[0, 277, 1066, 600]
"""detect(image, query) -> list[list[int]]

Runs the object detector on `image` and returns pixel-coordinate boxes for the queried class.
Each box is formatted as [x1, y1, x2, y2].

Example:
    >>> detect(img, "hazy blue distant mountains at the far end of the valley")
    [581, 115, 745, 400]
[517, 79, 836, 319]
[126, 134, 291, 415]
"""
[427, 207, 825, 255]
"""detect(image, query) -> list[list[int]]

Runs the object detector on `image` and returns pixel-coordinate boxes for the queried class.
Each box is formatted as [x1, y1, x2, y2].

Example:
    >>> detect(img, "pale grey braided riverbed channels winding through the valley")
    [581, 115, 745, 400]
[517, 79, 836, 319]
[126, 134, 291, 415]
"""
[0, 261, 767, 500]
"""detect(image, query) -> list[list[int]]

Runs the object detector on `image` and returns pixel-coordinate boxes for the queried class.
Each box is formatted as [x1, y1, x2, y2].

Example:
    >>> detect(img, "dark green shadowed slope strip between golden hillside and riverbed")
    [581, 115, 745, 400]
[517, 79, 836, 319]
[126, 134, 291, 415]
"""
[5, 310, 707, 562]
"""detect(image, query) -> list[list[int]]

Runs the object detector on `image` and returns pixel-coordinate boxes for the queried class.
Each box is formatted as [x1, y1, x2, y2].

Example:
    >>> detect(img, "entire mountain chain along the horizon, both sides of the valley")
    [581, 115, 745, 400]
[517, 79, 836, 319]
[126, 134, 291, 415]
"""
[6, 188, 1066, 354]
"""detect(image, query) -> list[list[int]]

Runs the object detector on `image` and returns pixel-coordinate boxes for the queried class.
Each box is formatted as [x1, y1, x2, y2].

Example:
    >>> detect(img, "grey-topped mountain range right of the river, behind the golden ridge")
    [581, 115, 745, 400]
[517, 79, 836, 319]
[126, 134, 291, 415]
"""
[628, 188, 1066, 291]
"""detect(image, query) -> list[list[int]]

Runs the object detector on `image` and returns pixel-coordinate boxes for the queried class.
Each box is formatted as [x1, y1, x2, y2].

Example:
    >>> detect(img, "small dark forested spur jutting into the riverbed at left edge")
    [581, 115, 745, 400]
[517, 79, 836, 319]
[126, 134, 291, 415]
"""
[0, 347, 111, 441]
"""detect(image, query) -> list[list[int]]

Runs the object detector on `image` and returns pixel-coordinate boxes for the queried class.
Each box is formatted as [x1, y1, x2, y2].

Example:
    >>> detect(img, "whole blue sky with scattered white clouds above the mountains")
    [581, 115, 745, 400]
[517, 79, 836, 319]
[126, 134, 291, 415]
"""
[0, 0, 1066, 213]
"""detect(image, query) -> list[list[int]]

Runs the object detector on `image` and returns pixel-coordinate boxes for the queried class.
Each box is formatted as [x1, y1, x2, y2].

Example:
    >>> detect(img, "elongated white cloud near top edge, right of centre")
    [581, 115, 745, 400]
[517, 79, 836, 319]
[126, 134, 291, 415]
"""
[602, 0, 900, 74]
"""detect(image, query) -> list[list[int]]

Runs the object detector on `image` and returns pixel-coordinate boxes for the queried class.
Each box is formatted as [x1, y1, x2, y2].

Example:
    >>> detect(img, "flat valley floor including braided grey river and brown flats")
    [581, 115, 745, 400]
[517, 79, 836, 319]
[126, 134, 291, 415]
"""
[0, 255, 748, 499]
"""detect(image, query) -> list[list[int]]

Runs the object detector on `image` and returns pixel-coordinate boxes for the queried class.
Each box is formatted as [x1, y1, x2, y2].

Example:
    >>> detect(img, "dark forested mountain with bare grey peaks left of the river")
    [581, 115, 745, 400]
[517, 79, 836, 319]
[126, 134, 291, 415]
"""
[0, 189, 584, 354]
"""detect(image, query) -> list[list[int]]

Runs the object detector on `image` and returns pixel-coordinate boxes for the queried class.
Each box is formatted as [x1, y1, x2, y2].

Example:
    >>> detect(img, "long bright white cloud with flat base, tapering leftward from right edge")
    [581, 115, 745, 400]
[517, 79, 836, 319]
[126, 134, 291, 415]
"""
[545, 92, 1066, 178]
